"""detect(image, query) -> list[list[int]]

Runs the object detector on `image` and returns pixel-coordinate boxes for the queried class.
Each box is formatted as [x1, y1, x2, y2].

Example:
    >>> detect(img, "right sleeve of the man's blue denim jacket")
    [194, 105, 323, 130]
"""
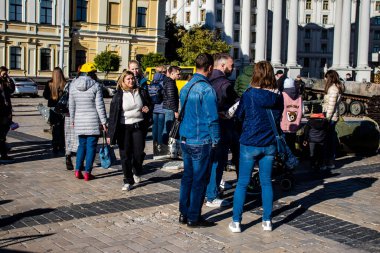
[202, 89, 220, 144]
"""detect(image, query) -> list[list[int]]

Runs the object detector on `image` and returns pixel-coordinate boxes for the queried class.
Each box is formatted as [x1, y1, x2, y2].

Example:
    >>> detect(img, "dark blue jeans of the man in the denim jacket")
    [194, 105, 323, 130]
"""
[179, 143, 211, 222]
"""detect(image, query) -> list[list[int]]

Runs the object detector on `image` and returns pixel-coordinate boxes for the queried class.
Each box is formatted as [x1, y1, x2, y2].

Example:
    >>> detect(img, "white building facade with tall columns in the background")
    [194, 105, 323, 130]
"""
[166, 0, 380, 81]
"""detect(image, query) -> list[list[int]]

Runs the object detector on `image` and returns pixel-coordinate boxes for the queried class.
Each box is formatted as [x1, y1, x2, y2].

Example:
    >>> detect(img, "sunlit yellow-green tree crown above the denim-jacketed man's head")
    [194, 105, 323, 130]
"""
[177, 26, 231, 65]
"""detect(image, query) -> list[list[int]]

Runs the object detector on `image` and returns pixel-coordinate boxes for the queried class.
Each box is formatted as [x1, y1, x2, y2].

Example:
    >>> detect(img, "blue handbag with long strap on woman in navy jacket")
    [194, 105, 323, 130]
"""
[266, 109, 299, 169]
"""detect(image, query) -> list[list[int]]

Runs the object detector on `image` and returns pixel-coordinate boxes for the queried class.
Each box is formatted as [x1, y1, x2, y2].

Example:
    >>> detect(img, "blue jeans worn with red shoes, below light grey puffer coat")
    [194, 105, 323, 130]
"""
[75, 135, 99, 173]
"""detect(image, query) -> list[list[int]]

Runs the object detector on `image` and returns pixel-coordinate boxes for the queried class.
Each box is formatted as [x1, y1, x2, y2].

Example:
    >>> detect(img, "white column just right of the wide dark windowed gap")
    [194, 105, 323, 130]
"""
[332, 0, 343, 68]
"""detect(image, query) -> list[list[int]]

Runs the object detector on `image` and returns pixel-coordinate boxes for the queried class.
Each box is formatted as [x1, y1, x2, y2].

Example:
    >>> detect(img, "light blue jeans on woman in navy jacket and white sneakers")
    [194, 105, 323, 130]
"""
[232, 144, 276, 222]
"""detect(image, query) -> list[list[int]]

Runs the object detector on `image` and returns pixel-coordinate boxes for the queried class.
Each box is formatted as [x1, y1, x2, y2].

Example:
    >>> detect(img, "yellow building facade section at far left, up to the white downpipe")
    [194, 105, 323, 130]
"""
[0, 0, 70, 78]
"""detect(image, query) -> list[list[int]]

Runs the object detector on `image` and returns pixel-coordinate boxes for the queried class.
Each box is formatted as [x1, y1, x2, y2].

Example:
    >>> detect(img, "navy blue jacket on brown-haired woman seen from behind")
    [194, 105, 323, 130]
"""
[235, 88, 284, 147]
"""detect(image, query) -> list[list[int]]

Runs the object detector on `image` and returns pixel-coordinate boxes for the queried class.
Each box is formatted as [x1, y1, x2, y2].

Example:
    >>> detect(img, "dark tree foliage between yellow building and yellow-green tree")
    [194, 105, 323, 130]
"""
[165, 17, 185, 62]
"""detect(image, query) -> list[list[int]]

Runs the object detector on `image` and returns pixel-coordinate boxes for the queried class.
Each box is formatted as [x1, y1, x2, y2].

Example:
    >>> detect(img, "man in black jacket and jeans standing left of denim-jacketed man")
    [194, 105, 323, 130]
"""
[162, 66, 181, 145]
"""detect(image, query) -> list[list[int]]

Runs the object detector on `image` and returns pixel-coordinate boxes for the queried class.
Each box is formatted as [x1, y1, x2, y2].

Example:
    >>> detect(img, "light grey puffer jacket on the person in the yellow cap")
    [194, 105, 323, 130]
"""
[69, 76, 107, 135]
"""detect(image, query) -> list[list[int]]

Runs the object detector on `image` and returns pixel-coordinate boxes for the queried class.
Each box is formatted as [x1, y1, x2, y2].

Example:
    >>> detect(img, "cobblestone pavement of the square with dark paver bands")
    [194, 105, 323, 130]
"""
[0, 98, 380, 253]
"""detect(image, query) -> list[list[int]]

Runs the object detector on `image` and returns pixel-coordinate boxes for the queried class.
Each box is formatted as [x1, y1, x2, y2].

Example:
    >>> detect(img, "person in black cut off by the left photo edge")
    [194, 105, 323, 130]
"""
[0, 66, 15, 161]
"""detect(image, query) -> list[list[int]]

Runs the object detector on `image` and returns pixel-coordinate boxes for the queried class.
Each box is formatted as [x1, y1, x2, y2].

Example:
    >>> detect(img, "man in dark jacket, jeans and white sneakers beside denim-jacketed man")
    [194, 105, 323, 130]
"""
[206, 53, 239, 207]
